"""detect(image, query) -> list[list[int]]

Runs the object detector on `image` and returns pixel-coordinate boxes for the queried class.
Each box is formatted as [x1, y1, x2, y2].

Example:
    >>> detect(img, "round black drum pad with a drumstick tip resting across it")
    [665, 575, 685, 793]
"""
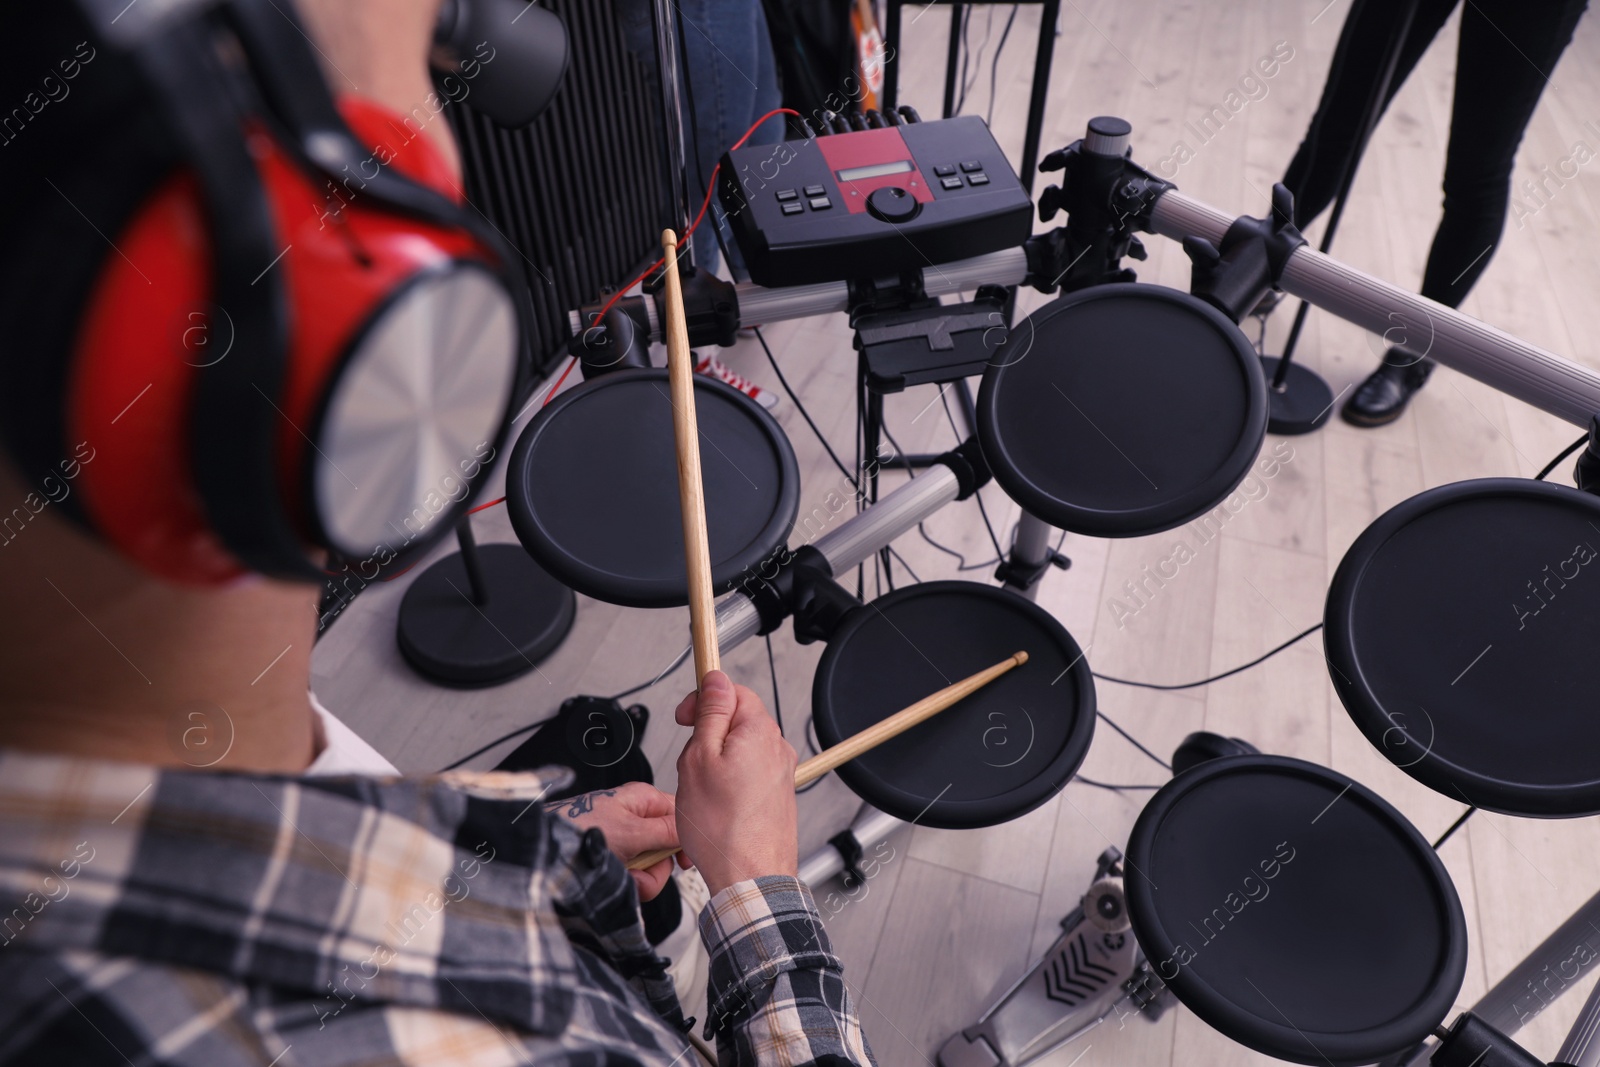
[811, 582, 1094, 829]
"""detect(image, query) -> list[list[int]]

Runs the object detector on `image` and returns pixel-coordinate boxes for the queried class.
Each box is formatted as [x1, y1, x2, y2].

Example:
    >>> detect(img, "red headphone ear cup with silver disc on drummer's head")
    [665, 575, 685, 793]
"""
[66, 101, 522, 584]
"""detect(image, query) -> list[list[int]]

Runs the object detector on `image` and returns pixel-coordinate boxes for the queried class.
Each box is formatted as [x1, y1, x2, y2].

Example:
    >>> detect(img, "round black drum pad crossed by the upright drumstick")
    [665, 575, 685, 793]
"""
[506, 368, 800, 608]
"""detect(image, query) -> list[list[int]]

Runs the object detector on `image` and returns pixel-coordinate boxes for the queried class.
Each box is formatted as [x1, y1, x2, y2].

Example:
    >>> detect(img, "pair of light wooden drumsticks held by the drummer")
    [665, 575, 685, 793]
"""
[629, 230, 1027, 870]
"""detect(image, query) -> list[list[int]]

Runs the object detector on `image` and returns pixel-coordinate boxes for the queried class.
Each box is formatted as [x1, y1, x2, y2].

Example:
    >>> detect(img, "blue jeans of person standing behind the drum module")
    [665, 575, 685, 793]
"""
[614, 0, 784, 274]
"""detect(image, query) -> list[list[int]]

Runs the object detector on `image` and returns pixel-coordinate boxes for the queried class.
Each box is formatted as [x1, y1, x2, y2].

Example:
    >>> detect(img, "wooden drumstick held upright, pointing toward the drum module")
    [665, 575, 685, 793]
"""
[661, 230, 722, 686]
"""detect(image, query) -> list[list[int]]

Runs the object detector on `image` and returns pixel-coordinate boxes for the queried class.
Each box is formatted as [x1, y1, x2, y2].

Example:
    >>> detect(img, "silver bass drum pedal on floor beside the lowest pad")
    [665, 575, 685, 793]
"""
[939, 848, 1171, 1067]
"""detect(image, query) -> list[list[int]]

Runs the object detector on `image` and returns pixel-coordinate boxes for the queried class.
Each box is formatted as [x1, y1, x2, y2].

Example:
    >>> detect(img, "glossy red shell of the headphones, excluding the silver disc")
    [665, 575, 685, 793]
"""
[67, 98, 490, 584]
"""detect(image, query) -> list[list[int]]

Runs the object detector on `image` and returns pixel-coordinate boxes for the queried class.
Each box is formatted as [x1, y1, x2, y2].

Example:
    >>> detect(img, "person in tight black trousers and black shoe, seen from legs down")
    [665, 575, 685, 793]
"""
[1283, 0, 1587, 427]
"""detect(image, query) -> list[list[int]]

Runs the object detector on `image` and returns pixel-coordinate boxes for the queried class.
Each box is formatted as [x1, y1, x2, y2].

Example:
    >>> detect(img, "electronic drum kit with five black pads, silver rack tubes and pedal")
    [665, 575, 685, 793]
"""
[507, 120, 1600, 1067]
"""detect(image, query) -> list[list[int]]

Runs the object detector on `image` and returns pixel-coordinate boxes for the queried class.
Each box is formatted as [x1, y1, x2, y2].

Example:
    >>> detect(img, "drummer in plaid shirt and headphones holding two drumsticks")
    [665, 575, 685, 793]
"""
[0, 0, 870, 1067]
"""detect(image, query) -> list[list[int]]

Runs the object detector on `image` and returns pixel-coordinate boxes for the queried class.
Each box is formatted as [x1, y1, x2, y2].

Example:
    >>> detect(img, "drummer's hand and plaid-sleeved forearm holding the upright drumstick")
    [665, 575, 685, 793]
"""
[677, 670, 875, 1067]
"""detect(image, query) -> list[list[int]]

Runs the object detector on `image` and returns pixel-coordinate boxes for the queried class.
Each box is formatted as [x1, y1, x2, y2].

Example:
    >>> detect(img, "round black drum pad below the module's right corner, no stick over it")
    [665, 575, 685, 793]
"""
[978, 285, 1267, 537]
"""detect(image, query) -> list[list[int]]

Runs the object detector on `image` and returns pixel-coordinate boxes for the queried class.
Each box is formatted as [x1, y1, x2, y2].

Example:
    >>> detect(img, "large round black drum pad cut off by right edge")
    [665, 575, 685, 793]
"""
[1323, 478, 1600, 816]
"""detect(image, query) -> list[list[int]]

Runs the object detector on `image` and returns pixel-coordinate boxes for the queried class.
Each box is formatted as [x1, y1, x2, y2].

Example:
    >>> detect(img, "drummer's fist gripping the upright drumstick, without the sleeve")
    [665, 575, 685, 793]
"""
[677, 670, 800, 896]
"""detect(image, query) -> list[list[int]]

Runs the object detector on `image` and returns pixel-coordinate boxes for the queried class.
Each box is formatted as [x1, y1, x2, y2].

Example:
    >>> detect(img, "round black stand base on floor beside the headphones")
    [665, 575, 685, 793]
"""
[395, 520, 578, 688]
